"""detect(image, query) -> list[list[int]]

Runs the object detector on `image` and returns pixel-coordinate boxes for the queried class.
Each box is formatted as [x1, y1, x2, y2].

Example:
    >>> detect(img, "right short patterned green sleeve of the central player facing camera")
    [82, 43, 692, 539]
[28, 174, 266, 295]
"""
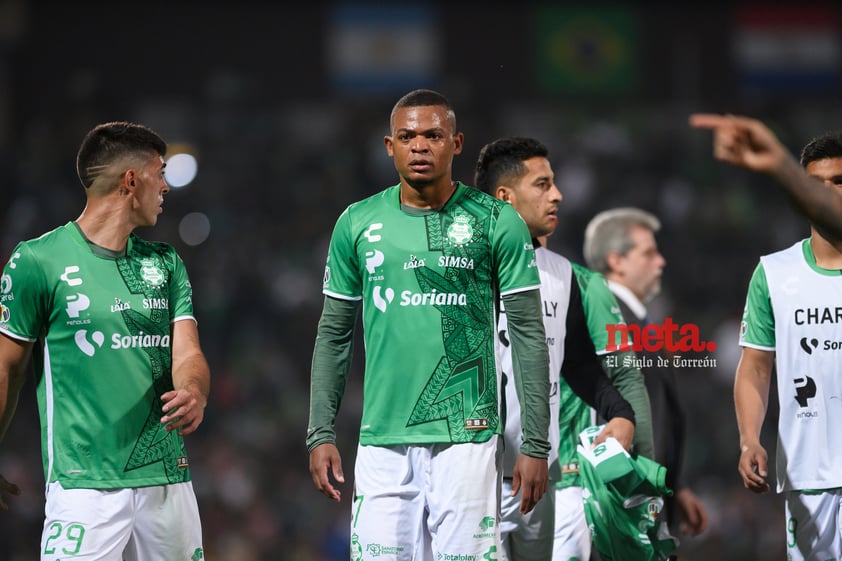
[492, 204, 541, 296]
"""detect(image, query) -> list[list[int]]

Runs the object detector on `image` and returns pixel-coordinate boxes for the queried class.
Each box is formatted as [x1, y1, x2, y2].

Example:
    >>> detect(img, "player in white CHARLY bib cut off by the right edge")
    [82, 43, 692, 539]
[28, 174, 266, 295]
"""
[734, 132, 842, 561]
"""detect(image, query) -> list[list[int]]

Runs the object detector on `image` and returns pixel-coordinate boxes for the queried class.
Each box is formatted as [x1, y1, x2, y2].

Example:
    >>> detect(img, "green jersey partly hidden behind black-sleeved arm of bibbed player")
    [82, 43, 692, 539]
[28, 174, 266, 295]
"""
[558, 263, 625, 487]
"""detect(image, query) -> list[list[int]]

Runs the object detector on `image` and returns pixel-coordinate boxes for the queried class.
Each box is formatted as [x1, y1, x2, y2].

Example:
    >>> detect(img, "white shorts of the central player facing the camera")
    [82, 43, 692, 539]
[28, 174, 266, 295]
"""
[351, 436, 501, 561]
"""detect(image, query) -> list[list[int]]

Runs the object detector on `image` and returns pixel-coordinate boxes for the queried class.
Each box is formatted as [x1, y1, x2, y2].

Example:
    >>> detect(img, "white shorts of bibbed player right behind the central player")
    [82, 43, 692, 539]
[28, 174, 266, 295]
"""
[500, 479, 555, 561]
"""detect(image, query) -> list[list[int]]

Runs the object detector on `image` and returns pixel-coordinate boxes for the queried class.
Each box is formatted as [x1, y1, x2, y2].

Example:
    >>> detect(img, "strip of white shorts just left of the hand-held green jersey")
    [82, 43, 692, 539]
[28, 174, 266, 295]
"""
[552, 486, 591, 561]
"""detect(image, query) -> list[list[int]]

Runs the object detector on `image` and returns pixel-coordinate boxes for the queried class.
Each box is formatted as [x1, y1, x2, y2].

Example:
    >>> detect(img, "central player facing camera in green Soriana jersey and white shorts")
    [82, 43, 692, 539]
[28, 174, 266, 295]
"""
[307, 90, 550, 561]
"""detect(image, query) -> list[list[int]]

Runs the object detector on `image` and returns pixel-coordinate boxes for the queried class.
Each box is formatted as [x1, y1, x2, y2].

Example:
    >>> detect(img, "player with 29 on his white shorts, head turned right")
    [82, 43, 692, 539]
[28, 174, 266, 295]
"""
[0, 122, 210, 561]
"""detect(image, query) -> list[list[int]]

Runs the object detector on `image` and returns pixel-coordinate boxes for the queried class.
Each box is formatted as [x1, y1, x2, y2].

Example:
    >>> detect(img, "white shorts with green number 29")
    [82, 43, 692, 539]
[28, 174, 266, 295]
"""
[41, 476, 203, 561]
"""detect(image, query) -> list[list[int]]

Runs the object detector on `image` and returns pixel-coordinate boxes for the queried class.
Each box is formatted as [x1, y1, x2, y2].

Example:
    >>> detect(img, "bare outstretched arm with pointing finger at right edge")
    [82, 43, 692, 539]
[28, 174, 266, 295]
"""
[690, 113, 842, 239]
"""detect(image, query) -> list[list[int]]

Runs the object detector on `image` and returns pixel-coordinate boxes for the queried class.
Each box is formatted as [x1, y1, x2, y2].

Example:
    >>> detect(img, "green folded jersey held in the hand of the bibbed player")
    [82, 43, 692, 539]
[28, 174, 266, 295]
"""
[577, 426, 678, 561]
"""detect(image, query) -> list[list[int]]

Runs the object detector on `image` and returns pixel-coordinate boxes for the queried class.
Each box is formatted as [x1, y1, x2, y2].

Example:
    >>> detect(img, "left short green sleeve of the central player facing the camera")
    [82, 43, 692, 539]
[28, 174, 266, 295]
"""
[322, 207, 362, 300]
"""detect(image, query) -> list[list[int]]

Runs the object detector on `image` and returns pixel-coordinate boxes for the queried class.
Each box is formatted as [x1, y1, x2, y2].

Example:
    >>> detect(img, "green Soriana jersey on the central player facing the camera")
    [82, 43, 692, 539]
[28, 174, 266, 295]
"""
[323, 183, 540, 446]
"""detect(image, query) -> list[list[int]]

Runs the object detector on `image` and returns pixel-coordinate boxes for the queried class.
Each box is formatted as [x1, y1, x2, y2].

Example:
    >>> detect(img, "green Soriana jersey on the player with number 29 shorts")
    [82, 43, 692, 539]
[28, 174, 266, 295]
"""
[0, 222, 193, 489]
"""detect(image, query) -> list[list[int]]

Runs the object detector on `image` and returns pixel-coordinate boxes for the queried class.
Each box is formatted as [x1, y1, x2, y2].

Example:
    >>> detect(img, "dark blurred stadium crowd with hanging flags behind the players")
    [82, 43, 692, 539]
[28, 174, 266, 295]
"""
[0, 0, 842, 561]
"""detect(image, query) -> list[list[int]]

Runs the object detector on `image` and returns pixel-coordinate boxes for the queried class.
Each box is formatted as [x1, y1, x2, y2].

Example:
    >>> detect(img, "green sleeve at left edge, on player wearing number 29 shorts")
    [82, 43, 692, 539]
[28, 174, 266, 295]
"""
[0, 242, 49, 342]
